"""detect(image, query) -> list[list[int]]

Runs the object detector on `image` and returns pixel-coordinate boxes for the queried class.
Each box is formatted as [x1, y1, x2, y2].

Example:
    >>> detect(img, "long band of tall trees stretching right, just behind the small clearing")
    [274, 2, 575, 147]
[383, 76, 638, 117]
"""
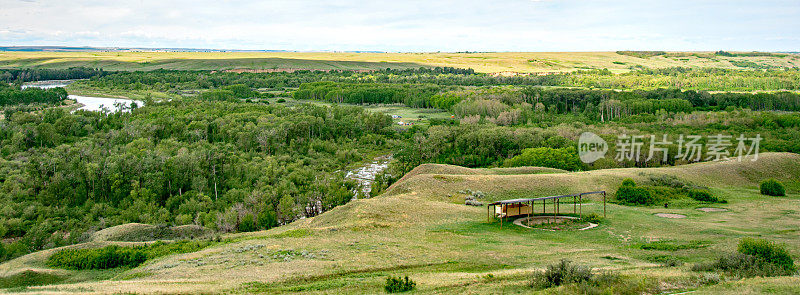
[293, 82, 800, 121]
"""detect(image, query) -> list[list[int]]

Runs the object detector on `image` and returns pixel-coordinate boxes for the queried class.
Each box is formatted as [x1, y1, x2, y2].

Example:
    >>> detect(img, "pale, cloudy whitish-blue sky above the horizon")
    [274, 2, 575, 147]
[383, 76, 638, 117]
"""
[0, 0, 800, 52]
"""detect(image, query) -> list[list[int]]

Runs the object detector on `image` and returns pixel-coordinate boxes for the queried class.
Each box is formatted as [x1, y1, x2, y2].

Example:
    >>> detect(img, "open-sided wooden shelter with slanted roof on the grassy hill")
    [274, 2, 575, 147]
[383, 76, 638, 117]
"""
[486, 191, 606, 227]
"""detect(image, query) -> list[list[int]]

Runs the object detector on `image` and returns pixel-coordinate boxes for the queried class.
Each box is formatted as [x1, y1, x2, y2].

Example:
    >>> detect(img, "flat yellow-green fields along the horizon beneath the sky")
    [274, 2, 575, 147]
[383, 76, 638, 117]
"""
[0, 51, 800, 74]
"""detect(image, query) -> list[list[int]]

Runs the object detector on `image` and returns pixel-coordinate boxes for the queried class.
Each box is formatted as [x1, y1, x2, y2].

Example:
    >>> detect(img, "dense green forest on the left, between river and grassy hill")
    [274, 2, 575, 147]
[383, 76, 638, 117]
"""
[0, 99, 396, 257]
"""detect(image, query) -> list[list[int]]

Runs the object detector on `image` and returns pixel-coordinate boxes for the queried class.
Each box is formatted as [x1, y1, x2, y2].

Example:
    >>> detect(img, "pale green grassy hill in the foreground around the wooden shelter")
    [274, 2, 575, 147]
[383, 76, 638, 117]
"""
[0, 153, 800, 294]
